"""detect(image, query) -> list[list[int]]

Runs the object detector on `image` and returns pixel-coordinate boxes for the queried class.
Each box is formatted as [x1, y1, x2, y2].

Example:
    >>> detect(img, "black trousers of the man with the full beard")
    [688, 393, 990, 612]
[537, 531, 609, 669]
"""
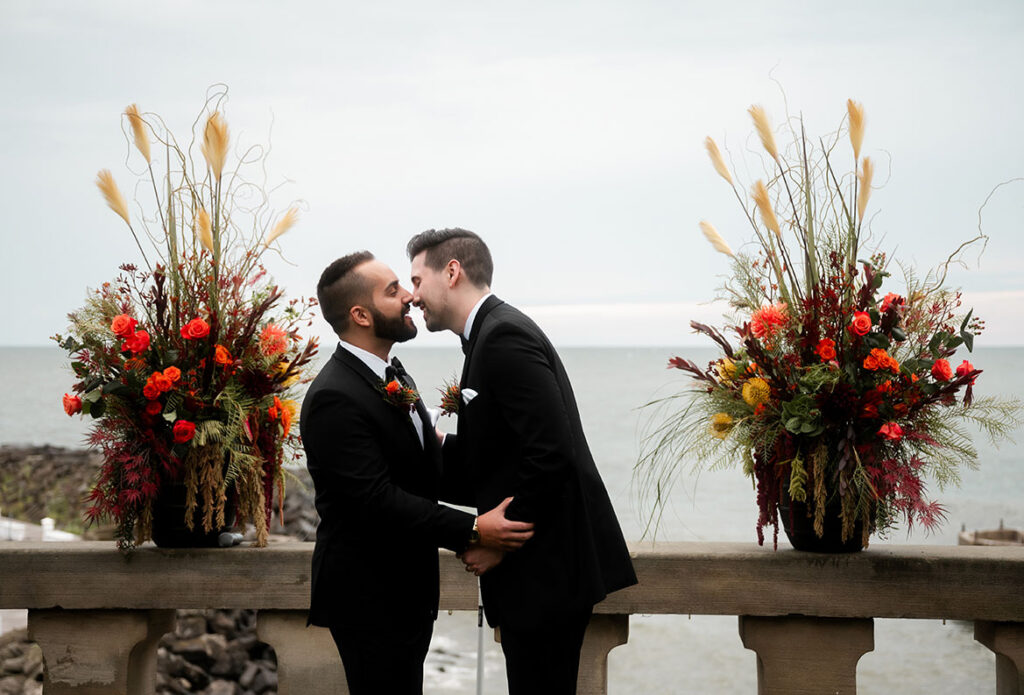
[331, 615, 434, 695]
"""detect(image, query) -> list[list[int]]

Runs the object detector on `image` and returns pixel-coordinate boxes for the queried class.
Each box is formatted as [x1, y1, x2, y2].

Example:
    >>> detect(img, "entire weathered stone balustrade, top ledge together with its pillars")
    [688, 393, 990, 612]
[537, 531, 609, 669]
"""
[0, 542, 1024, 695]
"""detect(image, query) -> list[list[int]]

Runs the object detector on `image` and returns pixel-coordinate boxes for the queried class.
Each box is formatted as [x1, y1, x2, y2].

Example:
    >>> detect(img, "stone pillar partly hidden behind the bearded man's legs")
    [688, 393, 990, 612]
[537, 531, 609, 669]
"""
[256, 610, 348, 695]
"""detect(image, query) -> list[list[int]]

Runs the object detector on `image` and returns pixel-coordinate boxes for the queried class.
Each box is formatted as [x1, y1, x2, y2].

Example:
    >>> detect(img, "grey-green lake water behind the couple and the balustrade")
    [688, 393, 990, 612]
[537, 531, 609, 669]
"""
[0, 346, 1024, 695]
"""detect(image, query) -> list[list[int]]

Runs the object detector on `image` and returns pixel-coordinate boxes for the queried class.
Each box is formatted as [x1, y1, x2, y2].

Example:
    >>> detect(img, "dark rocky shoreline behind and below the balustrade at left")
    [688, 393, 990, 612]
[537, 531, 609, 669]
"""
[0, 445, 317, 695]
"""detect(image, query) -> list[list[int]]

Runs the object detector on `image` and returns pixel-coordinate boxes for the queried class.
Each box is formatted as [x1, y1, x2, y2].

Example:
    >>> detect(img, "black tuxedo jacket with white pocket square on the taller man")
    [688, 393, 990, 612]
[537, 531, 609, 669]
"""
[444, 296, 637, 629]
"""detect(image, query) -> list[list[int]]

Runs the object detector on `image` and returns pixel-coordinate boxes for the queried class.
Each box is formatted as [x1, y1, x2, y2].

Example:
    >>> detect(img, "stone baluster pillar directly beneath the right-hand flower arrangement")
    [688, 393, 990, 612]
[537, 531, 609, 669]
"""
[739, 615, 874, 695]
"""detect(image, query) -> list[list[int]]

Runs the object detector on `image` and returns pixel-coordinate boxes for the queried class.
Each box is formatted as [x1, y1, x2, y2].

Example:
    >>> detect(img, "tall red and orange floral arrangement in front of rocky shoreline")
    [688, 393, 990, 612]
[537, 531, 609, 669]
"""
[54, 91, 316, 550]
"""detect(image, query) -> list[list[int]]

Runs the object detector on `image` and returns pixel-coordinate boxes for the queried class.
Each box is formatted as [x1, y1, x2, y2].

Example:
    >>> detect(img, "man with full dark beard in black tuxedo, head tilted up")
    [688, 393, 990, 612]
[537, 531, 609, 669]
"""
[300, 251, 532, 695]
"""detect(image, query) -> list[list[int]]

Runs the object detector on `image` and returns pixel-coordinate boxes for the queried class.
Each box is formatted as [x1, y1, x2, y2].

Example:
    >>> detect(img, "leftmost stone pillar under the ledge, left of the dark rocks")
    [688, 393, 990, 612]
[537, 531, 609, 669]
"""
[29, 609, 174, 695]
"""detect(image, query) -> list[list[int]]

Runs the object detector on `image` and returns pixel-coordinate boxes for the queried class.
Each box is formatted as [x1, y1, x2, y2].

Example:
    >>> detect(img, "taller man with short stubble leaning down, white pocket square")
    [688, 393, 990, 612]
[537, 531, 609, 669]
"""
[407, 229, 637, 695]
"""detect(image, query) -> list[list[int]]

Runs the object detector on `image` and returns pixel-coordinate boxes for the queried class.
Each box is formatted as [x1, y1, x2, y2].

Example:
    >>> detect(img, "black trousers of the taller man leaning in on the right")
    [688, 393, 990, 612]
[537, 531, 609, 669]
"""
[501, 609, 593, 695]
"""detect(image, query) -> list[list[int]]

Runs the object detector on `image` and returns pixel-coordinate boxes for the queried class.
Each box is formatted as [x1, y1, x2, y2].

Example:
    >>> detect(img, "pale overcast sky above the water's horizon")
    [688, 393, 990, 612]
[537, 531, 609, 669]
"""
[0, 0, 1024, 345]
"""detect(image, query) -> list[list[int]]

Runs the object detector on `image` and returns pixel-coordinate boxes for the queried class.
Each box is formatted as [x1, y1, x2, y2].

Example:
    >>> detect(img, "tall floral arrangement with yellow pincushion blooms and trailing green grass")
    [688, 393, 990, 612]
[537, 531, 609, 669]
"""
[636, 100, 1019, 547]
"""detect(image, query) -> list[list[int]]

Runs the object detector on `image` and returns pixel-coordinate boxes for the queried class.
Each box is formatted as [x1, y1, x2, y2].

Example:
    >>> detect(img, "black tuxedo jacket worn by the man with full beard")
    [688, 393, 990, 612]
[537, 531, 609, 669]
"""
[300, 345, 473, 626]
